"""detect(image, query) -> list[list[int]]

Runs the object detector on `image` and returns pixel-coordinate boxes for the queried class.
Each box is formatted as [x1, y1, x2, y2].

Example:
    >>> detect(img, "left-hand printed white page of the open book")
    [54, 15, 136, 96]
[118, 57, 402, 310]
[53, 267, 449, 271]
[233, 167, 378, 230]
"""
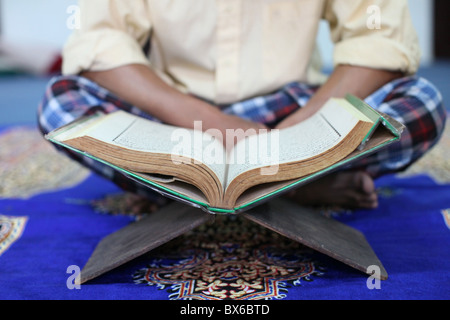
[64, 111, 225, 188]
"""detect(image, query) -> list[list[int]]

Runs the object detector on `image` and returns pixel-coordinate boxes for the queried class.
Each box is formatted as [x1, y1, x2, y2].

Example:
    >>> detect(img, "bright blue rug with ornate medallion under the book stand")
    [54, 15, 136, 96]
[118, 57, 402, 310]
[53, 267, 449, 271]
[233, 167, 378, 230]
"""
[0, 125, 450, 300]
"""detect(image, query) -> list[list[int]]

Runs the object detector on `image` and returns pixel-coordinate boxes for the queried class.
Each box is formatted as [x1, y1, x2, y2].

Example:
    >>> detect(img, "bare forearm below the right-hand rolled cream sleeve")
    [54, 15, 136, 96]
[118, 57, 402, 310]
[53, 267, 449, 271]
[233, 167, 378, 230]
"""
[277, 65, 402, 129]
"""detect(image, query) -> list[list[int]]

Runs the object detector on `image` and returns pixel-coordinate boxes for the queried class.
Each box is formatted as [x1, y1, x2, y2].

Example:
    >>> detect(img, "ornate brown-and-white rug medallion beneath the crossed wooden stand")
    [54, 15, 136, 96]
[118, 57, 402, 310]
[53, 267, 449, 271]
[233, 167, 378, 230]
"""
[133, 217, 324, 300]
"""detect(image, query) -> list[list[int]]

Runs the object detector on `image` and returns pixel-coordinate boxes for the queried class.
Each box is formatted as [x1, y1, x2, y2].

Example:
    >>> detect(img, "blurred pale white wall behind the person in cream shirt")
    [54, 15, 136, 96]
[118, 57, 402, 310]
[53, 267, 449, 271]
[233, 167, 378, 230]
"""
[0, 0, 433, 66]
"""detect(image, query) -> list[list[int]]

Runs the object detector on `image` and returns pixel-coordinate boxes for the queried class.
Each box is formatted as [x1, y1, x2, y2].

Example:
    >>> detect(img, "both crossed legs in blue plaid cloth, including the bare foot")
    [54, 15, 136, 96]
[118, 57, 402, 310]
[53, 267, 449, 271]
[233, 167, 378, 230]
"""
[38, 76, 446, 208]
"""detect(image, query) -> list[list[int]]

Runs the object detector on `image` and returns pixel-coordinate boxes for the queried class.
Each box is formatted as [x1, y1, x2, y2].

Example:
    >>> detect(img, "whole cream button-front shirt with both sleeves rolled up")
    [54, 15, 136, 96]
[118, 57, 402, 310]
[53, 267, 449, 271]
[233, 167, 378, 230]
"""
[63, 0, 420, 103]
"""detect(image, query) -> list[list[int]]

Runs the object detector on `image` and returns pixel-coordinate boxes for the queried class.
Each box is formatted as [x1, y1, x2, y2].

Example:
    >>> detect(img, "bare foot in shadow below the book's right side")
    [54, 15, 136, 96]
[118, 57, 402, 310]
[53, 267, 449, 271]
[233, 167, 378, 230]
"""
[288, 171, 378, 209]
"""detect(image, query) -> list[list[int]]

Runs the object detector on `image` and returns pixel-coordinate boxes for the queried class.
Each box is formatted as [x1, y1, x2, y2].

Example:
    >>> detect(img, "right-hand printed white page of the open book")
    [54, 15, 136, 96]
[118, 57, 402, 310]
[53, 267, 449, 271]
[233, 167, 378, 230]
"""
[227, 100, 358, 184]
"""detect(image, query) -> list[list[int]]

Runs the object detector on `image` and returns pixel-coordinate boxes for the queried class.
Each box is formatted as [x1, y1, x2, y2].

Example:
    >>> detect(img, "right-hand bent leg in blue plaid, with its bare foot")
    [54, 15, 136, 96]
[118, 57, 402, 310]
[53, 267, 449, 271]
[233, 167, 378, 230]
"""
[284, 77, 446, 209]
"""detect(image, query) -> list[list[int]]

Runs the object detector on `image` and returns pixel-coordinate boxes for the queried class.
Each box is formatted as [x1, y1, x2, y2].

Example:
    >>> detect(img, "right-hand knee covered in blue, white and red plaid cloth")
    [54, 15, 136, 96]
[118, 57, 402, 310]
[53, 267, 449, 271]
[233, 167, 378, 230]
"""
[368, 77, 447, 176]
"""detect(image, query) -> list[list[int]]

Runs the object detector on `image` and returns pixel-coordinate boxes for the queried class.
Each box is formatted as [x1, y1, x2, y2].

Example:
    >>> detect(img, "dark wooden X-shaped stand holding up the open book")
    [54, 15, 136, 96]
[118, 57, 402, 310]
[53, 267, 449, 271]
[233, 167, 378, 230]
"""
[80, 199, 388, 283]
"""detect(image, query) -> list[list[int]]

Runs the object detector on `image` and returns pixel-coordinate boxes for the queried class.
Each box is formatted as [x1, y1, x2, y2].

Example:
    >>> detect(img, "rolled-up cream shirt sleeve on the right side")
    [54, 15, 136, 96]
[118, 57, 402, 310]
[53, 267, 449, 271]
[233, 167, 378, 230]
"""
[324, 0, 420, 74]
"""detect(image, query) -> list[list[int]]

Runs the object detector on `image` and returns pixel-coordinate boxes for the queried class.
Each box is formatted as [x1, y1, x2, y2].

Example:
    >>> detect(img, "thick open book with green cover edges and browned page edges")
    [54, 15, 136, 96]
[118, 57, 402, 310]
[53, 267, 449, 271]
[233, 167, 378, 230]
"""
[46, 96, 402, 213]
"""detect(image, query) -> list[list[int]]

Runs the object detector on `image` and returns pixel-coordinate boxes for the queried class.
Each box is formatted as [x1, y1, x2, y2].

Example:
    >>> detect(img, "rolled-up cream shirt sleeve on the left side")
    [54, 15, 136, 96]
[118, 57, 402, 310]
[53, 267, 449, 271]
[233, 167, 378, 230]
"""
[63, 0, 151, 75]
